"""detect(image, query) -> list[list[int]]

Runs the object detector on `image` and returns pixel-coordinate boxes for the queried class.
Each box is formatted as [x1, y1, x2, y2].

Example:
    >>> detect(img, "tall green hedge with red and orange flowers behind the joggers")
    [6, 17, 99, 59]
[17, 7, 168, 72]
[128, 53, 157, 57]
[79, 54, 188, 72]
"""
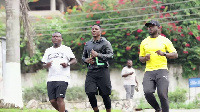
[0, 0, 195, 77]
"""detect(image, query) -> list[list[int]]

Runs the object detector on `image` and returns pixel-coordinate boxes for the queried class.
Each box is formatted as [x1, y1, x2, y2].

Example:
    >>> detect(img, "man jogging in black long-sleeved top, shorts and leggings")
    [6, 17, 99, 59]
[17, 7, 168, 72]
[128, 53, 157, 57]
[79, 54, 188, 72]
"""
[82, 25, 113, 112]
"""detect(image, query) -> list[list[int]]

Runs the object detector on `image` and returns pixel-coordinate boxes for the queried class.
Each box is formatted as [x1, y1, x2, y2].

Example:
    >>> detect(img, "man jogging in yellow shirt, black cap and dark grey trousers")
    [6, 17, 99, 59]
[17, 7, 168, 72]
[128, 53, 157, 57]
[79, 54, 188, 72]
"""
[139, 20, 178, 112]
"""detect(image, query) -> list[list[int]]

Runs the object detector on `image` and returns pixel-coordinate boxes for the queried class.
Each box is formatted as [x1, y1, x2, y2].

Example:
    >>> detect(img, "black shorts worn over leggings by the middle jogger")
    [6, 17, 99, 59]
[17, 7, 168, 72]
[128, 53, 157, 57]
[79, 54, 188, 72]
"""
[85, 68, 112, 95]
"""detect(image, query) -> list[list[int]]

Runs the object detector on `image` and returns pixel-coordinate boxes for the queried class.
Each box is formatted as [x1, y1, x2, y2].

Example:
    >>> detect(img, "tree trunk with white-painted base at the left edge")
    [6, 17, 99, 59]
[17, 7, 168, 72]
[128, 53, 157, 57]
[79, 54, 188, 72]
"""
[3, 0, 23, 107]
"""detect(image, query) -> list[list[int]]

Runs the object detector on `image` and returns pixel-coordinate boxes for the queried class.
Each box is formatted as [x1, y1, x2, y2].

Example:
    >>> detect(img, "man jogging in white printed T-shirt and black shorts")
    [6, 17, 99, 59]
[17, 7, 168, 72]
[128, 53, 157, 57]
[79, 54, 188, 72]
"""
[42, 32, 77, 112]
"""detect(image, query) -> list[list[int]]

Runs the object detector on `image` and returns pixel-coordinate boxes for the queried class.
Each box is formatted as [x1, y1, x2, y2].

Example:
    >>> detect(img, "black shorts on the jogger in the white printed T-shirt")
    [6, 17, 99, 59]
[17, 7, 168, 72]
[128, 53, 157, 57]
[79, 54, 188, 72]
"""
[47, 81, 68, 100]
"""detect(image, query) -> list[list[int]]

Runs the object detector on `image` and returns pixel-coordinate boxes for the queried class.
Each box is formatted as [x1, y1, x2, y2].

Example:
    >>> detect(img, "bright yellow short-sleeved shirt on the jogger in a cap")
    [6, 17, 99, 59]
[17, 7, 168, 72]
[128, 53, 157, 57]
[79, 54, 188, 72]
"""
[140, 35, 176, 71]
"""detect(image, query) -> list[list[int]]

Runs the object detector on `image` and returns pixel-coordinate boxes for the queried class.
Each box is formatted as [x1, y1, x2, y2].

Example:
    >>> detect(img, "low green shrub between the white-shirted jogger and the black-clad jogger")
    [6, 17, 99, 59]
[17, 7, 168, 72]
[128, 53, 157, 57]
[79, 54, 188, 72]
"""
[66, 86, 87, 101]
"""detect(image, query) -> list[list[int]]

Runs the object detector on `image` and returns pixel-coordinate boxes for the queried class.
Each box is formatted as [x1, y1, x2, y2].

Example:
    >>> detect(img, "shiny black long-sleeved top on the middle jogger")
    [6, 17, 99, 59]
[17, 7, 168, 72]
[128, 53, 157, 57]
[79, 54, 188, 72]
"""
[82, 37, 113, 70]
